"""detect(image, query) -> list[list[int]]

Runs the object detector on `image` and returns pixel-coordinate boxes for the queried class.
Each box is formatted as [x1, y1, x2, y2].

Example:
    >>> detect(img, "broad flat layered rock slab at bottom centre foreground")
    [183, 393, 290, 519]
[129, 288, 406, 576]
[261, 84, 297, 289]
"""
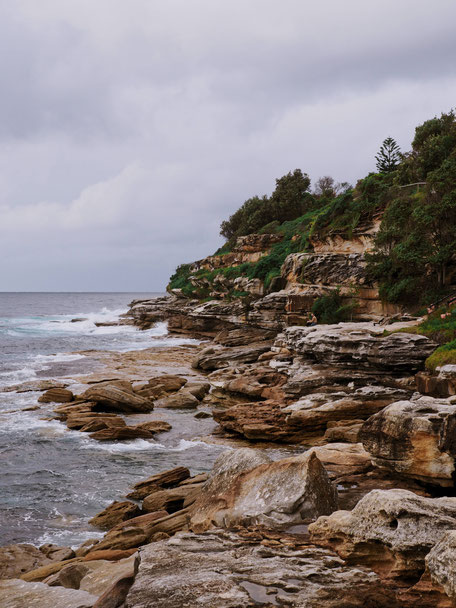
[126, 530, 399, 608]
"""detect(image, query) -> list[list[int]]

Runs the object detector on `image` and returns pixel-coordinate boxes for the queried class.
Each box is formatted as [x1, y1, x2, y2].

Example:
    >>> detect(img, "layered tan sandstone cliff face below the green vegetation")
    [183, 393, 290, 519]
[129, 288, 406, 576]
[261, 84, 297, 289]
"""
[169, 217, 400, 328]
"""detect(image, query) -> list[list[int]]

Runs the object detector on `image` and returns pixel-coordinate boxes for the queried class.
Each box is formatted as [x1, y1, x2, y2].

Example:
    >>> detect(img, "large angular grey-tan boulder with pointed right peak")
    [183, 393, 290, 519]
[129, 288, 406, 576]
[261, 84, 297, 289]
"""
[190, 448, 338, 532]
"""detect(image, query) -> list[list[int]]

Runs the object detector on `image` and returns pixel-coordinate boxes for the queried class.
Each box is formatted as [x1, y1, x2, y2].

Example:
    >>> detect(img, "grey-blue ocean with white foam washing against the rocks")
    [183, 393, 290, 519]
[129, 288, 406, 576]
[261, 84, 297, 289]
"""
[0, 293, 226, 546]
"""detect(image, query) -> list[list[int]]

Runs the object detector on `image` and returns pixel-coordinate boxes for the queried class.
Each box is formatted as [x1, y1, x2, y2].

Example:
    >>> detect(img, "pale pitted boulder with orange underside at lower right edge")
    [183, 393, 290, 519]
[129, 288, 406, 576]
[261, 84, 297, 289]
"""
[309, 490, 456, 580]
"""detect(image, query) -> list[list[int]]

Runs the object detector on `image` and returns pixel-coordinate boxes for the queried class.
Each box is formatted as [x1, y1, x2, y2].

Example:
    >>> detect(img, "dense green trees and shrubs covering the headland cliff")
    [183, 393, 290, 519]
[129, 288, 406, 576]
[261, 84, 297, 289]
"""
[170, 112, 456, 306]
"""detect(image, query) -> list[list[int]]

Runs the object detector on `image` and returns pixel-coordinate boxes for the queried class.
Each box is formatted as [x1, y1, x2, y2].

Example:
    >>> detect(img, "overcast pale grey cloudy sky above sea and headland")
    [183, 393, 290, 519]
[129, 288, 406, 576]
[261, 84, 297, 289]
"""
[0, 0, 456, 291]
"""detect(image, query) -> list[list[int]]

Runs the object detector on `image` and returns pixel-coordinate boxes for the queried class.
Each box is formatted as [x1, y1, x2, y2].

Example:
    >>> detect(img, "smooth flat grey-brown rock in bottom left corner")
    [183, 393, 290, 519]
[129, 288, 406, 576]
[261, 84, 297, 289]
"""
[0, 579, 97, 608]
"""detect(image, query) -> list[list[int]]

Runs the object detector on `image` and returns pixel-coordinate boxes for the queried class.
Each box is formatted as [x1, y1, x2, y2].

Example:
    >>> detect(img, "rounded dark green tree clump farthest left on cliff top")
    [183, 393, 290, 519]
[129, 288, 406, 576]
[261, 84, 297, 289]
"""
[220, 169, 314, 240]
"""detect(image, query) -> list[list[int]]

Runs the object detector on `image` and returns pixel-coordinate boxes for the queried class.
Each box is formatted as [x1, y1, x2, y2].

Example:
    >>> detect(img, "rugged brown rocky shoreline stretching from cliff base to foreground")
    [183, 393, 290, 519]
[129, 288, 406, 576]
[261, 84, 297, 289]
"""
[0, 292, 456, 608]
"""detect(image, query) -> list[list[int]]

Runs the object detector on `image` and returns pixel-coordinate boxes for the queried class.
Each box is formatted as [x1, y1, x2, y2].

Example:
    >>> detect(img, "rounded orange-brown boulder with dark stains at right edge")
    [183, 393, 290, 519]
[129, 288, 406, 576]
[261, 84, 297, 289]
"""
[359, 397, 456, 487]
